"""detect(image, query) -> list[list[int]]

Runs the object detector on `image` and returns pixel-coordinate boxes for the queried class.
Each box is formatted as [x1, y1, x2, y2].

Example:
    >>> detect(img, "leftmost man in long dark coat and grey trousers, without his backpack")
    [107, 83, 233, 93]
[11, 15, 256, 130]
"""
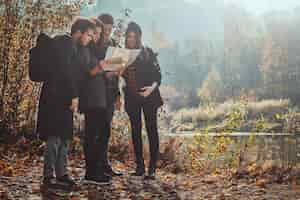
[37, 19, 95, 186]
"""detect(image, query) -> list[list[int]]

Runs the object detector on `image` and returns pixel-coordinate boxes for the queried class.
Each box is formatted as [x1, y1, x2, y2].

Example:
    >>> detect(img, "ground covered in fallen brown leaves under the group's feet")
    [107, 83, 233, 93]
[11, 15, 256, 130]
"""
[0, 138, 300, 200]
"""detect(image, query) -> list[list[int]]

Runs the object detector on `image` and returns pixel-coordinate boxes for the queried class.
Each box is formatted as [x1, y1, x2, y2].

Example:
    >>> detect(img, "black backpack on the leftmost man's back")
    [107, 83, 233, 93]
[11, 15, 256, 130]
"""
[29, 33, 55, 82]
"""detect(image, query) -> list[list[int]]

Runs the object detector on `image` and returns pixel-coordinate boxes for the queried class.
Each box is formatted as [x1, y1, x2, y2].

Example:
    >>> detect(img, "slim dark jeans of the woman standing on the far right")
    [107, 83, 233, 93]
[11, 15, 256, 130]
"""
[126, 103, 159, 172]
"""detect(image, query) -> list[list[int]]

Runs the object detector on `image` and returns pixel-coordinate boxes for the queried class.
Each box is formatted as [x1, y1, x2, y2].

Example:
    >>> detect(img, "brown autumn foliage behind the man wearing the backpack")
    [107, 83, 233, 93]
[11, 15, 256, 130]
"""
[0, 0, 92, 141]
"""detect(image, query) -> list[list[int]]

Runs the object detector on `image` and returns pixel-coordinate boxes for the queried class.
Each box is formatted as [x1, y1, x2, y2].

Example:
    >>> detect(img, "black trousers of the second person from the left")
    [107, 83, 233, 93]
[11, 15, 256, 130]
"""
[84, 109, 110, 177]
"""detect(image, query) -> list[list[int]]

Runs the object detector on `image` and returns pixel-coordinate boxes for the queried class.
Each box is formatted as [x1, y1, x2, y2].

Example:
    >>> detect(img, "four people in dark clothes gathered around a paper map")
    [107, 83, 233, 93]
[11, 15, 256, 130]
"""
[37, 14, 163, 186]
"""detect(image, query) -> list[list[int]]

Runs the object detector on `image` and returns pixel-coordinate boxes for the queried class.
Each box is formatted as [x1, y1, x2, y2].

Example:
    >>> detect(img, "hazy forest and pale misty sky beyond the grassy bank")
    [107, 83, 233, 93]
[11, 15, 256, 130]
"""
[82, 0, 300, 117]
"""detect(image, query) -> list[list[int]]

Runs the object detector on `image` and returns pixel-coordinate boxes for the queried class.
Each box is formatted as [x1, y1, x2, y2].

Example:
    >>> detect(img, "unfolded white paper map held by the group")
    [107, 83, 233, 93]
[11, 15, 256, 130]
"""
[105, 47, 141, 71]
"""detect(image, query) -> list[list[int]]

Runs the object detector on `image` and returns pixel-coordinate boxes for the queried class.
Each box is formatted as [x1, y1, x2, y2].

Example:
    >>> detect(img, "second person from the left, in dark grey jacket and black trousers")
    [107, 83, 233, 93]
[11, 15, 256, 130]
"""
[79, 19, 110, 184]
